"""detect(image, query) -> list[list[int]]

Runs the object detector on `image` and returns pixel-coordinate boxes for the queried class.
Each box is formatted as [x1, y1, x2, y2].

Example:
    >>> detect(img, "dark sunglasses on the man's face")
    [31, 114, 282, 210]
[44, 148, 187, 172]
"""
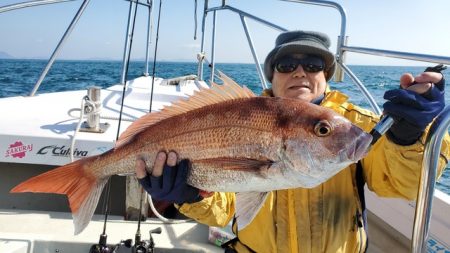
[275, 55, 325, 73]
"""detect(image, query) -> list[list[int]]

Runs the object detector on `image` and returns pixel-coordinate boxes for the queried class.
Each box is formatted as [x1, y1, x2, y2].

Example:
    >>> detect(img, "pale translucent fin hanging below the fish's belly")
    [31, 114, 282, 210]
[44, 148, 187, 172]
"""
[235, 192, 269, 230]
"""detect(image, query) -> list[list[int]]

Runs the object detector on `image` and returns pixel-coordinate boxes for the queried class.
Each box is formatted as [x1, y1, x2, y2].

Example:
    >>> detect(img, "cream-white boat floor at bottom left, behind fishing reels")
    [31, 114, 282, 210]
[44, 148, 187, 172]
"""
[0, 209, 223, 253]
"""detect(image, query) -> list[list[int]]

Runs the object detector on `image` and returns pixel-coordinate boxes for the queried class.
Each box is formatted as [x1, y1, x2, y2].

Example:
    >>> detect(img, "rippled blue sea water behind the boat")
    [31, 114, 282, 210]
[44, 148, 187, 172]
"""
[0, 59, 450, 194]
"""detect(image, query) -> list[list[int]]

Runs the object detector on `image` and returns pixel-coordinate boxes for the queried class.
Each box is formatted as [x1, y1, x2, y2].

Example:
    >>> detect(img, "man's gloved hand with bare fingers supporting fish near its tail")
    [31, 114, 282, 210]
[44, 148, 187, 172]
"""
[136, 152, 202, 204]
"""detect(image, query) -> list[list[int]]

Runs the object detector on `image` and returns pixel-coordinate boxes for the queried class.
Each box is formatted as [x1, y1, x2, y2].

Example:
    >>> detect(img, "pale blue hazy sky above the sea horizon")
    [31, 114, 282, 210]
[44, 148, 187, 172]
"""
[0, 0, 450, 65]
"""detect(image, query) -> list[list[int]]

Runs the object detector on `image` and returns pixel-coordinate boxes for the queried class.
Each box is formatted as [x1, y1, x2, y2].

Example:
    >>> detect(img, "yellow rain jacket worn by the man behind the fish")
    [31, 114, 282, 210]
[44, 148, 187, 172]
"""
[179, 88, 450, 253]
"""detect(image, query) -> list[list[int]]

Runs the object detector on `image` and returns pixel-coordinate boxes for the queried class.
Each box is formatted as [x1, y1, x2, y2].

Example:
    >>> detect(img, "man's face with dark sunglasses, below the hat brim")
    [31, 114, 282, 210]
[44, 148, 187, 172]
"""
[272, 54, 327, 102]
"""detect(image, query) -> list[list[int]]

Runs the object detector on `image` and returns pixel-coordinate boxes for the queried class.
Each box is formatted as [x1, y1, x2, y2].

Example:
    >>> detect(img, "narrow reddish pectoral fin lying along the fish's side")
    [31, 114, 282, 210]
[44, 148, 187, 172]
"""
[192, 157, 273, 171]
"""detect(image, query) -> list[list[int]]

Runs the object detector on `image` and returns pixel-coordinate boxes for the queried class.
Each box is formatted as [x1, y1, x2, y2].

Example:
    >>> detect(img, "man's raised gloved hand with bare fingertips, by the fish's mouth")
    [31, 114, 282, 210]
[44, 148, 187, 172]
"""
[383, 69, 445, 145]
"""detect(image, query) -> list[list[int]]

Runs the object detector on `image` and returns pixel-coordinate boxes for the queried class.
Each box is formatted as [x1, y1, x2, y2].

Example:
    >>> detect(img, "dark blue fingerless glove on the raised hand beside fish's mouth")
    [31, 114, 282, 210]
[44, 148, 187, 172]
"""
[383, 69, 445, 145]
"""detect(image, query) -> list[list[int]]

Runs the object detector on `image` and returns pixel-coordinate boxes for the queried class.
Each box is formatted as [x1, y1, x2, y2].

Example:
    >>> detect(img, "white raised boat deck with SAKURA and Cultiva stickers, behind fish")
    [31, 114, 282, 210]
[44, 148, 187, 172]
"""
[0, 77, 206, 165]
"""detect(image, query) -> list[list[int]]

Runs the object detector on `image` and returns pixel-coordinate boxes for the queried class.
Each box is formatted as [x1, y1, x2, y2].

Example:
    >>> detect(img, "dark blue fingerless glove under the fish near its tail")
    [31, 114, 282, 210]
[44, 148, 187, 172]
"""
[138, 160, 202, 204]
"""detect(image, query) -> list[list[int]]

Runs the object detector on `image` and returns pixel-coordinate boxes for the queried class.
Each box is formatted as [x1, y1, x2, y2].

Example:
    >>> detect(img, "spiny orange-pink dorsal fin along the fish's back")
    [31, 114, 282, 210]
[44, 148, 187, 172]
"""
[116, 72, 256, 148]
